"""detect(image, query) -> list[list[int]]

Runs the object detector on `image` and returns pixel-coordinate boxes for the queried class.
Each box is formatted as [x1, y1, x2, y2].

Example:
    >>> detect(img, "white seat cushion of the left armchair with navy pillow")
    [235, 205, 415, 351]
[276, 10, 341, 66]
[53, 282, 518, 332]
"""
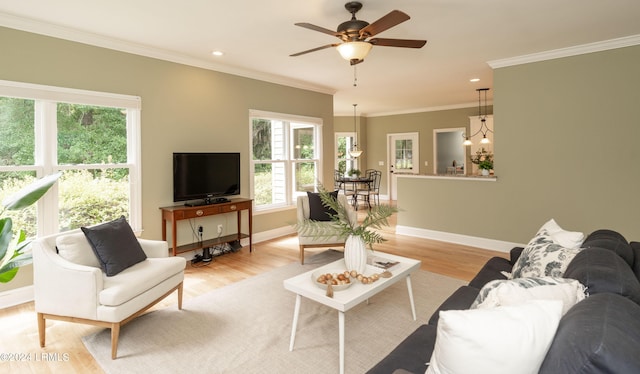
[98, 257, 185, 306]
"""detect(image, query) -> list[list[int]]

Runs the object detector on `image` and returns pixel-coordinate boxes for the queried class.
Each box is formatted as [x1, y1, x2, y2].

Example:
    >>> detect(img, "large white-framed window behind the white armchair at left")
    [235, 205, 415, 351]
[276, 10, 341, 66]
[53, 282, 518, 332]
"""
[0, 81, 142, 236]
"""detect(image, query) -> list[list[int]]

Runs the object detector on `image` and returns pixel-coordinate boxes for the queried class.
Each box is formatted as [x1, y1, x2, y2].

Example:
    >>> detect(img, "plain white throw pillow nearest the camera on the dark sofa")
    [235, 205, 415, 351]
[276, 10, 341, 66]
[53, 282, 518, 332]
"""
[427, 300, 562, 374]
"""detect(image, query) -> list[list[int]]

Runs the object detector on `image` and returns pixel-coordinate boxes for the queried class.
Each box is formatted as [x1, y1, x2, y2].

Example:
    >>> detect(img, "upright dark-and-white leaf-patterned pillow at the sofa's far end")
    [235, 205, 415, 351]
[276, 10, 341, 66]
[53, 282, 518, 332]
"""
[509, 229, 582, 279]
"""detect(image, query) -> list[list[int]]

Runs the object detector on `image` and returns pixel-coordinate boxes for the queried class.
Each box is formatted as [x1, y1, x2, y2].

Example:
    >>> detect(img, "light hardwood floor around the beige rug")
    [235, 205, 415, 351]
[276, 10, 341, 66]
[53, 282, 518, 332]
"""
[0, 206, 508, 373]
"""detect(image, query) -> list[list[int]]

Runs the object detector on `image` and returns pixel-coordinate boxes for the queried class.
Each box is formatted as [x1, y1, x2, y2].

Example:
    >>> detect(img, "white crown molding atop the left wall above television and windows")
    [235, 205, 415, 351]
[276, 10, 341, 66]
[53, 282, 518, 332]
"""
[0, 13, 336, 95]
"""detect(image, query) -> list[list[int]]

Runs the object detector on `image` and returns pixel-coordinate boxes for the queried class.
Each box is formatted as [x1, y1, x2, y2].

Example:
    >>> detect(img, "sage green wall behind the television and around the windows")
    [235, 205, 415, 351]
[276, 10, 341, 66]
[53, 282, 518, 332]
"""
[0, 28, 333, 291]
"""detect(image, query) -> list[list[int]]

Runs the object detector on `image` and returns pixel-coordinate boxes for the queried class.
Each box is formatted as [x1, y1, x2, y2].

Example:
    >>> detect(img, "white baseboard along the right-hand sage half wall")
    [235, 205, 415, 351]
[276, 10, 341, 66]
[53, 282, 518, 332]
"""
[396, 226, 526, 253]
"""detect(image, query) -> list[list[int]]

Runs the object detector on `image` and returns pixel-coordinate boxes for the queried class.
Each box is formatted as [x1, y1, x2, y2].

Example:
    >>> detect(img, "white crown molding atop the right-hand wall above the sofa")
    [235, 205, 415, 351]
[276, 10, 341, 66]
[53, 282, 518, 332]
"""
[487, 35, 640, 69]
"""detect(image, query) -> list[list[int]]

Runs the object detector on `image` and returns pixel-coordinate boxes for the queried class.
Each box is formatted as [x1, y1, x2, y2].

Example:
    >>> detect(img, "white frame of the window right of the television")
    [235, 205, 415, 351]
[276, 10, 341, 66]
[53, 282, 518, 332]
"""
[248, 109, 323, 212]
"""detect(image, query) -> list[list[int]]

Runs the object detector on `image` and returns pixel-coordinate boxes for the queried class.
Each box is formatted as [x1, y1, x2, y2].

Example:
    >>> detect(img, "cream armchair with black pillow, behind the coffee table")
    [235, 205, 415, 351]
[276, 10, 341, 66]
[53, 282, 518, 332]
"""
[297, 194, 358, 264]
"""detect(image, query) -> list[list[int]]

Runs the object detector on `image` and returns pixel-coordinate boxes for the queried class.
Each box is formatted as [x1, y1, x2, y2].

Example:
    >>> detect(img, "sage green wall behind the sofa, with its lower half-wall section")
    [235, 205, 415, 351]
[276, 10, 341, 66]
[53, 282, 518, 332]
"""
[398, 46, 640, 243]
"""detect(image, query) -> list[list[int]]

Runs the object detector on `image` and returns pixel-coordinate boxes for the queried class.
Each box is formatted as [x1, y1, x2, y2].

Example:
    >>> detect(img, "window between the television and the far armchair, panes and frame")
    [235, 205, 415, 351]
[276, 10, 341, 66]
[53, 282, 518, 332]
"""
[249, 111, 322, 210]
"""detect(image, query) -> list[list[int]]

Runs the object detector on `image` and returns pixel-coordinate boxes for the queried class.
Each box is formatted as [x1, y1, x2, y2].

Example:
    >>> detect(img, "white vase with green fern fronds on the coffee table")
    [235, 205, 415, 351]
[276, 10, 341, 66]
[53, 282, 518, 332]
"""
[298, 186, 398, 273]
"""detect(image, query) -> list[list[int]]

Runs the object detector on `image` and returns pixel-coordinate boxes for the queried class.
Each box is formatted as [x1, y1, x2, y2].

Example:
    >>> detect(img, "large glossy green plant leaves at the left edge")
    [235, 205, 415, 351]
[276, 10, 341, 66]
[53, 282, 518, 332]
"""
[0, 173, 61, 283]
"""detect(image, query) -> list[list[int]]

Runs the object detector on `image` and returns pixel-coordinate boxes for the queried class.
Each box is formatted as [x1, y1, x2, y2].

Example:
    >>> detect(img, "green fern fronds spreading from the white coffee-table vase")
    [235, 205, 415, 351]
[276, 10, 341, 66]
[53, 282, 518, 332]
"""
[297, 187, 398, 249]
